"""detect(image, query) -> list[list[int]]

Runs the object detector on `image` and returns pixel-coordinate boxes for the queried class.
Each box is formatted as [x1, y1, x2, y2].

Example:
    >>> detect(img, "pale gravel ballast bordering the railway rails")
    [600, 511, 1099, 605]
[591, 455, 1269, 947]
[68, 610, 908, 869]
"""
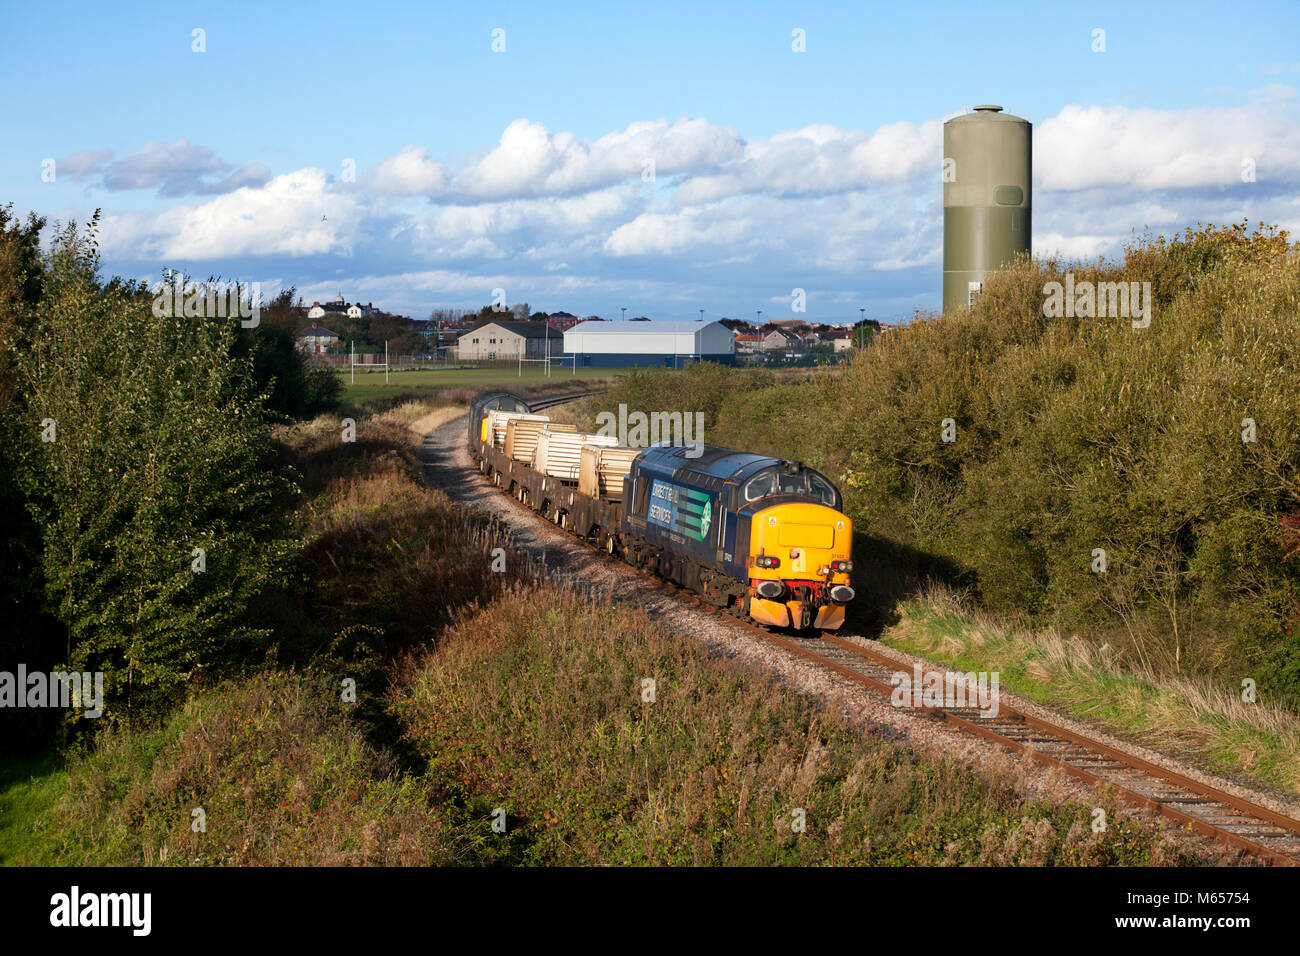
[421, 416, 1253, 861]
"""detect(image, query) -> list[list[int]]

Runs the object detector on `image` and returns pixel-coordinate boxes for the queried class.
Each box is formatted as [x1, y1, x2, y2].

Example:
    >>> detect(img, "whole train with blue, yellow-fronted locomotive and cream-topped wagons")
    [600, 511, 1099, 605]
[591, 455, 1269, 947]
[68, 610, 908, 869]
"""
[468, 392, 854, 630]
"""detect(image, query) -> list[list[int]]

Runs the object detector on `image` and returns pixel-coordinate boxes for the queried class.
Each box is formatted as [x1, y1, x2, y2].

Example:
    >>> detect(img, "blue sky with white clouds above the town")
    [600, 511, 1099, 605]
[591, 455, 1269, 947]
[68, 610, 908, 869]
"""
[0, 0, 1300, 321]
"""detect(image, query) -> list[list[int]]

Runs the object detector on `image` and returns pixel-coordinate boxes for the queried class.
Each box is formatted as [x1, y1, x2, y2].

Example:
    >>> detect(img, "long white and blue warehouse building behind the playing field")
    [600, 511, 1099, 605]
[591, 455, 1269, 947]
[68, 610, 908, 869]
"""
[564, 320, 736, 368]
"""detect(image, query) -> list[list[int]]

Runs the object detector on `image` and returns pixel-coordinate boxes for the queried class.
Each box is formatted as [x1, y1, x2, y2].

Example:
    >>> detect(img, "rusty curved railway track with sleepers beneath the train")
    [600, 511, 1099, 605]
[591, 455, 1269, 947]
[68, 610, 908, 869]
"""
[452, 392, 1300, 866]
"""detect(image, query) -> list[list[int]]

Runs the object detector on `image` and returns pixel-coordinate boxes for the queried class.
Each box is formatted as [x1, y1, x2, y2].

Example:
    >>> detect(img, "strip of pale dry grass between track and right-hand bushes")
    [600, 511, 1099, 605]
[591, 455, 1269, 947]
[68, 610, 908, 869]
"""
[884, 584, 1300, 795]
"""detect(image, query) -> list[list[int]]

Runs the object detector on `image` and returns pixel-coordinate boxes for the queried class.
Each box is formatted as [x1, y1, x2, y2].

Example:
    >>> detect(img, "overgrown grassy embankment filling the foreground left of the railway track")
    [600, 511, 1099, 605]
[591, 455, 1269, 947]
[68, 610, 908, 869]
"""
[0, 403, 1210, 865]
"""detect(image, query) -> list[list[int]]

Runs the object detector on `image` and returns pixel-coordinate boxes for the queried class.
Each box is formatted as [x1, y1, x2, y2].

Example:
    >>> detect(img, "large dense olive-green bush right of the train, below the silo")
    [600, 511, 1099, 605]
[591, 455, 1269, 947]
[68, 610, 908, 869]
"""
[835, 226, 1300, 670]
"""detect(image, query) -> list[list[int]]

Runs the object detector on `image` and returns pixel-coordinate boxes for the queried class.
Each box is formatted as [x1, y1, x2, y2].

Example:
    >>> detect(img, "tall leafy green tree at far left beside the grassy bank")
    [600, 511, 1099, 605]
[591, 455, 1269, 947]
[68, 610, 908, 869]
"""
[16, 213, 291, 715]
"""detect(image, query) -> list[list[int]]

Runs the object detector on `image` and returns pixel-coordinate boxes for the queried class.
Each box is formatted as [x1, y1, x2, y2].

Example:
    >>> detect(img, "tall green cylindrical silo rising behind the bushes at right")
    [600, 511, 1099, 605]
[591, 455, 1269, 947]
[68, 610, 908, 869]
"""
[944, 107, 1034, 312]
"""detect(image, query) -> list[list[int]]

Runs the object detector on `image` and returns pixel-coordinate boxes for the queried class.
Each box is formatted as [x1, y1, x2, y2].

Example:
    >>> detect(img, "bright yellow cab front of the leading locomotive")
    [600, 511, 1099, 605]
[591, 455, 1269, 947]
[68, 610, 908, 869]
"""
[746, 502, 854, 630]
